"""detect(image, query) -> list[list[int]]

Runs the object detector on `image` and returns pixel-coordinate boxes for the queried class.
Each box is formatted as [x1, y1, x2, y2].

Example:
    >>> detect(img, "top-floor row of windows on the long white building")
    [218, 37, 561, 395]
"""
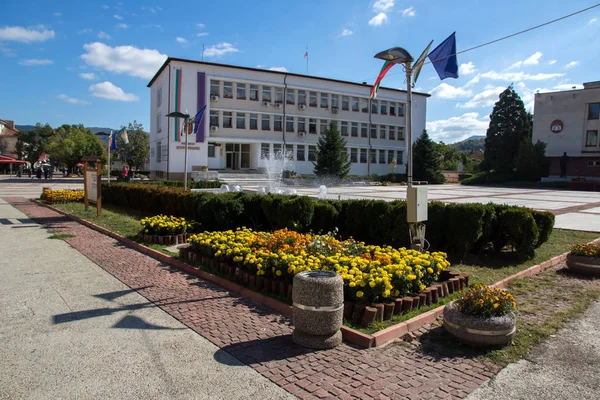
[210, 79, 404, 117]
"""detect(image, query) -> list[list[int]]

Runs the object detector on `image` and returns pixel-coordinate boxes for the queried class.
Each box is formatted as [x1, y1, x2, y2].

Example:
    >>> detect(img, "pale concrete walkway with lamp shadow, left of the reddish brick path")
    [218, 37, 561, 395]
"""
[0, 199, 293, 399]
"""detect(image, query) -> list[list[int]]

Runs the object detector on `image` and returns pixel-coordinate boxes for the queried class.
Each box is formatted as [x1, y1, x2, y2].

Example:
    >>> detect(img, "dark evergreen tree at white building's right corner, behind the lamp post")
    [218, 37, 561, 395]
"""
[413, 129, 445, 183]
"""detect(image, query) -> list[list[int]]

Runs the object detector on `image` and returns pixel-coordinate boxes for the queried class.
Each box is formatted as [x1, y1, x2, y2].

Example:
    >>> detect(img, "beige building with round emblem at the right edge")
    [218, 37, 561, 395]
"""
[533, 81, 600, 177]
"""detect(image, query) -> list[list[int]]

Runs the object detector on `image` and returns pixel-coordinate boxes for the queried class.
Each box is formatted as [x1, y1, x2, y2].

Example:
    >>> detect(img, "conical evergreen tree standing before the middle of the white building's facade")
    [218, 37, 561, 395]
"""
[313, 121, 352, 179]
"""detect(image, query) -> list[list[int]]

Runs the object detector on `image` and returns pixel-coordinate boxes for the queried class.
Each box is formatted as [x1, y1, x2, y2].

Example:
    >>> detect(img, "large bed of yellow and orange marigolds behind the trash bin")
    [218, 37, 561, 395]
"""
[182, 228, 467, 324]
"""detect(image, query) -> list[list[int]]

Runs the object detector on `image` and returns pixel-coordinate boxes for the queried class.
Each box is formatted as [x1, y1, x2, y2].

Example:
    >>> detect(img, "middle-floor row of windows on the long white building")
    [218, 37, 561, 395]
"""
[204, 110, 404, 140]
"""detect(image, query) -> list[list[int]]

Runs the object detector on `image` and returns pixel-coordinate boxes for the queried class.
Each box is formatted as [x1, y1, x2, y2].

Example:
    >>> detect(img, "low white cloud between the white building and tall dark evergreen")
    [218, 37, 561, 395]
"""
[427, 112, 490, 143]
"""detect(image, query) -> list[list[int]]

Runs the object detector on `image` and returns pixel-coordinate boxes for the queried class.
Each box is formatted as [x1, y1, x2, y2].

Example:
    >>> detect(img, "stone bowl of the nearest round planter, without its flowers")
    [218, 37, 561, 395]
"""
[444, 302, 517, 347]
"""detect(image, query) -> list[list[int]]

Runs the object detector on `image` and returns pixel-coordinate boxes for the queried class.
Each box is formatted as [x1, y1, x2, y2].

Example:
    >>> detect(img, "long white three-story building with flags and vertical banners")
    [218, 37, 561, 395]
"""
[148, 57, 429, 179]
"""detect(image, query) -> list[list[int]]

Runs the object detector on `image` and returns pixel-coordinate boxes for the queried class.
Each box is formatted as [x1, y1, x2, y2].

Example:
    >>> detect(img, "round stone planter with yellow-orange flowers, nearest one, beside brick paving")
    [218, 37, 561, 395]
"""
[444, 285, 517, 347]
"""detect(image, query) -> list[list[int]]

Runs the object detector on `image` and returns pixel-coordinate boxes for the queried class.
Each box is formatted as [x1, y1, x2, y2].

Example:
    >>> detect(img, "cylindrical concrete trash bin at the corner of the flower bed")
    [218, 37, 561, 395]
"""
[292, 271, 344, 349]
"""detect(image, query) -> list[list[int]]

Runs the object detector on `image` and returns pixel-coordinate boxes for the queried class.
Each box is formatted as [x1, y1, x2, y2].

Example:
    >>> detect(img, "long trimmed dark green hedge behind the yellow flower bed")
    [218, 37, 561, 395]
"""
[102, 183, 554, 260]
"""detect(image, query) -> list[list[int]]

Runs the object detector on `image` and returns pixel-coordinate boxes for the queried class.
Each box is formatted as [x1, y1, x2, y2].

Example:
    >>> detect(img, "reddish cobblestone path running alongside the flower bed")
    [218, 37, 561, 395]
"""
[5, 197, 499, 399]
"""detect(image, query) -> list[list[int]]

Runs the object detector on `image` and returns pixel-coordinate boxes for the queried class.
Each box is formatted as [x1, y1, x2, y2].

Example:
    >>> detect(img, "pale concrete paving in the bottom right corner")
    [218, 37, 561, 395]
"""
[467, 302, 600, 400]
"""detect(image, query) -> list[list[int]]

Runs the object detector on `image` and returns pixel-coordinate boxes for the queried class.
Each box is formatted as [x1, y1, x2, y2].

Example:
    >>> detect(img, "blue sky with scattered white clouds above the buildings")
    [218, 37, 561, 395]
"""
[0, 0, 600, 142]
